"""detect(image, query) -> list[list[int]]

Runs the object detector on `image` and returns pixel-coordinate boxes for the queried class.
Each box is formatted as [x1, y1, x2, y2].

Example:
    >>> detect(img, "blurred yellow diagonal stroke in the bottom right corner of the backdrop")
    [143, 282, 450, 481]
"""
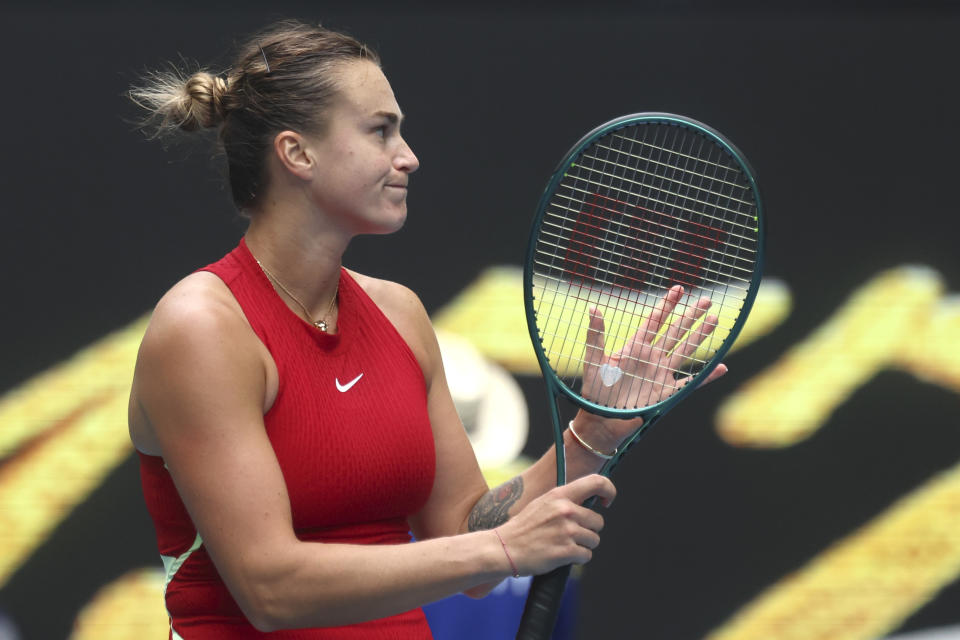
[709, 465, 960, 640]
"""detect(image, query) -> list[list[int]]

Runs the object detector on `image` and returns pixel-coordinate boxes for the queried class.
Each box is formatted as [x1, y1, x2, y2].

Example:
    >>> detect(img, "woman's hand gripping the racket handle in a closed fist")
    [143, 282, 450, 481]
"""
[498, 475, 617, 575]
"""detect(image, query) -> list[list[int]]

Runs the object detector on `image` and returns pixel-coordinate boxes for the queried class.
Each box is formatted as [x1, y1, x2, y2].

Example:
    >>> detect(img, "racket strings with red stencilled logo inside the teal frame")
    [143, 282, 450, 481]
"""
[534, 124, 757, 408]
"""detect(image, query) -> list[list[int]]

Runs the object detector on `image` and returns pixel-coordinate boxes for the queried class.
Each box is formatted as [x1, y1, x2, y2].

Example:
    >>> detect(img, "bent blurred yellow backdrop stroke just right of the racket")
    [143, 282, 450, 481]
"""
[717, 266, 948, 447]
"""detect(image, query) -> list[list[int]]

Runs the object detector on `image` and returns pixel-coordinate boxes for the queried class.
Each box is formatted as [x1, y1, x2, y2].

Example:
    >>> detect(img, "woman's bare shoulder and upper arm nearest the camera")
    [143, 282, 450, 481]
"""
[131, 279, 295, 610]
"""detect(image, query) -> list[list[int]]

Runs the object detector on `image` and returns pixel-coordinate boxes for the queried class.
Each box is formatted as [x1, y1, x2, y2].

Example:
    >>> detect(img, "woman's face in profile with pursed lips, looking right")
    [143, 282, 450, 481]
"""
[309, 60, 420, 233]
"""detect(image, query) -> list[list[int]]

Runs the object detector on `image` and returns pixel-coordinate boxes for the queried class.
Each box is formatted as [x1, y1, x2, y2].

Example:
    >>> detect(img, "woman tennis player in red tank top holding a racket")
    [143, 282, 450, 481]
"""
[129, 21, 724, 640]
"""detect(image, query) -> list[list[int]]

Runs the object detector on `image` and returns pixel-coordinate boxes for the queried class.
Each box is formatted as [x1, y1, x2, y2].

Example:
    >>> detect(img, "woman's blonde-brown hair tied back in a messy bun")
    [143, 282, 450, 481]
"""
[129, 20, 380, 210]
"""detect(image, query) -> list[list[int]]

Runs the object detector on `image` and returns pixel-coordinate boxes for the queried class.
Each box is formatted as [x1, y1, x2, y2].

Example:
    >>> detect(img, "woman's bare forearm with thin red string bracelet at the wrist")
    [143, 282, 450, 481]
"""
[235, 532, 512, 630]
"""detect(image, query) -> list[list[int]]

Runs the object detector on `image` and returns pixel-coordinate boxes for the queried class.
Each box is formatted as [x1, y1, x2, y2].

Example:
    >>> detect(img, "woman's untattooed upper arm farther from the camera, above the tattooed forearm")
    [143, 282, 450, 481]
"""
[356, 280, 487, 539]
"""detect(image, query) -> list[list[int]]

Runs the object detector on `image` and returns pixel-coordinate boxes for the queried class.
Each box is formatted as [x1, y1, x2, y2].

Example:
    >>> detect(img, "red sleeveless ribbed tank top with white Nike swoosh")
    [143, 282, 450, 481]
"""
[140, 240, 435, 640]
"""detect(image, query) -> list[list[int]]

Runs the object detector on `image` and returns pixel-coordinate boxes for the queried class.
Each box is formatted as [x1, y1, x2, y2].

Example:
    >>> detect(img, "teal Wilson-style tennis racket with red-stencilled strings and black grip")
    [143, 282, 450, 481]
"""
[517, 113, 764, 640]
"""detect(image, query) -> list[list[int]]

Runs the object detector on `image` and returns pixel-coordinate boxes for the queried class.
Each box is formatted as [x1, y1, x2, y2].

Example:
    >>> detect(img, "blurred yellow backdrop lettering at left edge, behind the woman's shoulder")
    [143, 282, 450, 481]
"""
[0, 319, 146, 587]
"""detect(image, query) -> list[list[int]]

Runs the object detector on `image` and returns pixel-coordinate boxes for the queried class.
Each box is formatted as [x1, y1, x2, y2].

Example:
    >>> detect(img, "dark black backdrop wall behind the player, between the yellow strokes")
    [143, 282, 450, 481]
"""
[0, 2, 960, 638]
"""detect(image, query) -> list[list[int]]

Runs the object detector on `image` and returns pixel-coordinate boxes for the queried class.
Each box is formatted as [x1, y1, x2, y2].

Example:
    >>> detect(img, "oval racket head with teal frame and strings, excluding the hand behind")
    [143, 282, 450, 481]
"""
[523, 113, 765, 428]
